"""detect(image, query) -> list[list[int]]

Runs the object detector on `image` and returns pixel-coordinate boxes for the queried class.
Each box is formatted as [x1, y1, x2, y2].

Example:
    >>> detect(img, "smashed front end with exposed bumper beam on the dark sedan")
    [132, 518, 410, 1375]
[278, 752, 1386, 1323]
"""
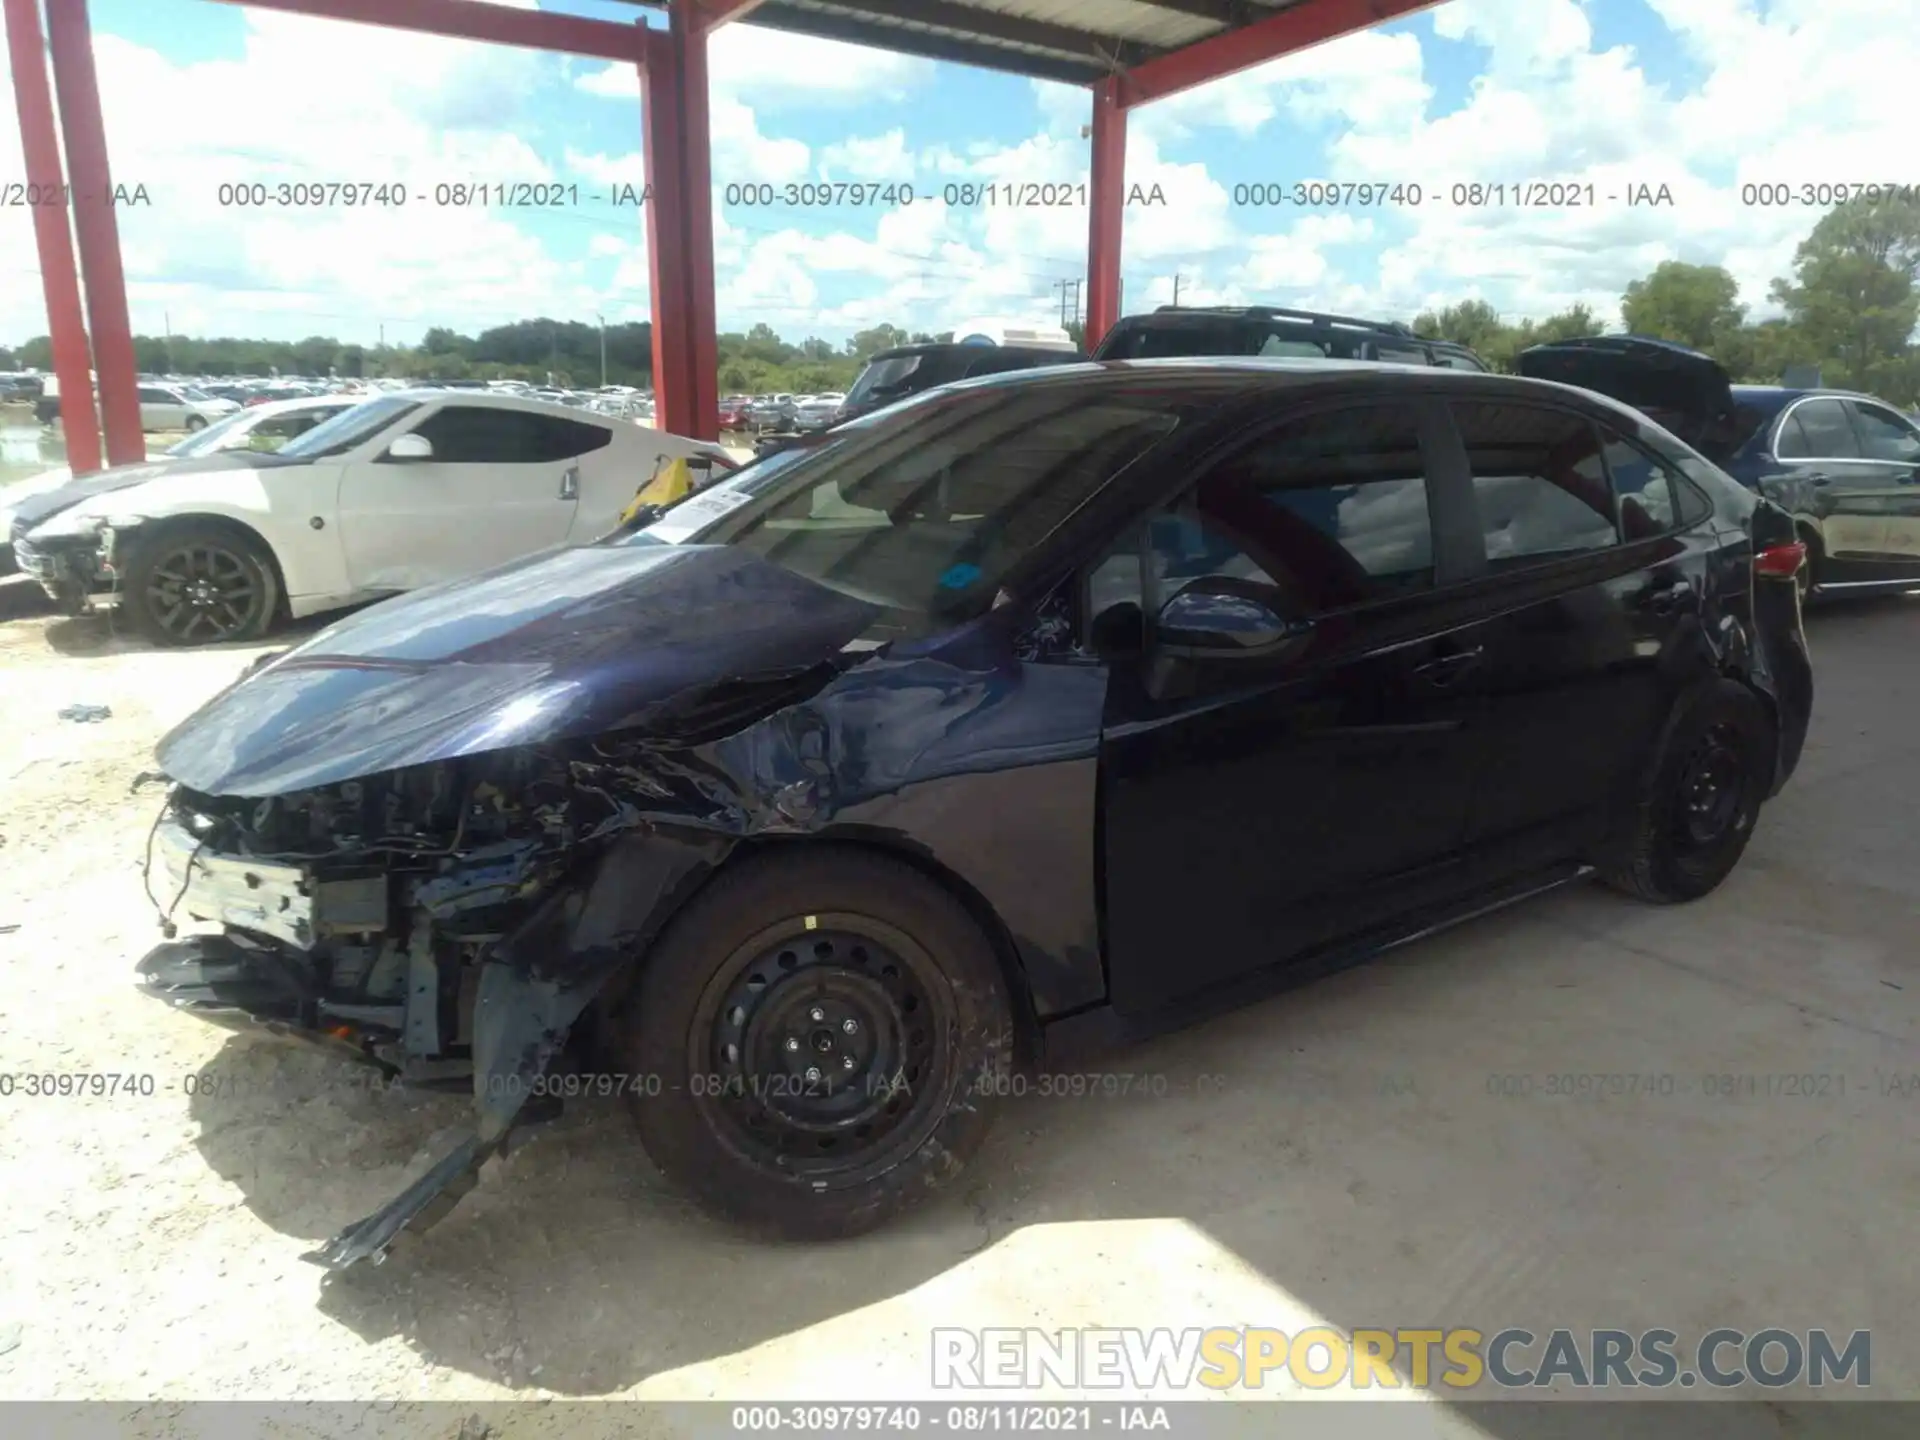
[138, 741, 741, 1267]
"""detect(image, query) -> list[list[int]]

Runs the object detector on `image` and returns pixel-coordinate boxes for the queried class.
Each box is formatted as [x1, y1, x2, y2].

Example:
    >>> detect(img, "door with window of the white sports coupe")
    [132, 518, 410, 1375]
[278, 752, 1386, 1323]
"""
[340, 403, 580, 591]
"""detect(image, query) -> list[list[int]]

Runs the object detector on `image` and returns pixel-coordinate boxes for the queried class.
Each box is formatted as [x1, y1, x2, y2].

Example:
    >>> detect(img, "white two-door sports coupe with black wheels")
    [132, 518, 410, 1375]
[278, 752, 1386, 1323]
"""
[13, 390, 735, 645]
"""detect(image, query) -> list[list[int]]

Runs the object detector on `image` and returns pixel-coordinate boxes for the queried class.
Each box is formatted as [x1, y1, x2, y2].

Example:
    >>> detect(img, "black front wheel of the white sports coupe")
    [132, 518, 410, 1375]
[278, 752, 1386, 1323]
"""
[121, 522, 280, 645]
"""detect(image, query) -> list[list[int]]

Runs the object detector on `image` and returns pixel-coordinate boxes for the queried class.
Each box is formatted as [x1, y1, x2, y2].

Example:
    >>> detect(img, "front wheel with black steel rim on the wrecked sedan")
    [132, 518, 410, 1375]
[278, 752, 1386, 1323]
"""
[622, 847, 1014, 1240]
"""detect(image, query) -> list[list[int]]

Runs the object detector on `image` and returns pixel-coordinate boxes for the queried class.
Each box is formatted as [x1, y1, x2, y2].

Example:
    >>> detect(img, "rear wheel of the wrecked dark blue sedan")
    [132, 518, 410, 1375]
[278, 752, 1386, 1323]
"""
[1601, 680, 1774, 904]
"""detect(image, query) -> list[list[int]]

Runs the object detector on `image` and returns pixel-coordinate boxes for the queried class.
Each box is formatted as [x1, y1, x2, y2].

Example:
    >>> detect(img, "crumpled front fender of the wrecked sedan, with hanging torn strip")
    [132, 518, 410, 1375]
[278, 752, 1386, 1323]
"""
[307, 622, 1106, 1269]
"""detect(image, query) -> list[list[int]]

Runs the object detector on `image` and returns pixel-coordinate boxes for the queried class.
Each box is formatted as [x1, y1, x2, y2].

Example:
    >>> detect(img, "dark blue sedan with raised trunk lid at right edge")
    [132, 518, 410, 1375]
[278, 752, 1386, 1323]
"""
[1519, 336, 1920, 595]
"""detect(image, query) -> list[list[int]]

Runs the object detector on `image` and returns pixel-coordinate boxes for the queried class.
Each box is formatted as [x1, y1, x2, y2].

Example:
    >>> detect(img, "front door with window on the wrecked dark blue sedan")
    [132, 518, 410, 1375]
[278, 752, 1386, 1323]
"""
[1089, 405, 1480, 1014]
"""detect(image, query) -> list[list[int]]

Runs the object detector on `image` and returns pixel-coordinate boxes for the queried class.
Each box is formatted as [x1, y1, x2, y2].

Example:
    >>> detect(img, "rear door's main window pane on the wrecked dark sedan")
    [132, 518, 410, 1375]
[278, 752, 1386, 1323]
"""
[1453, 401, 1619, 572]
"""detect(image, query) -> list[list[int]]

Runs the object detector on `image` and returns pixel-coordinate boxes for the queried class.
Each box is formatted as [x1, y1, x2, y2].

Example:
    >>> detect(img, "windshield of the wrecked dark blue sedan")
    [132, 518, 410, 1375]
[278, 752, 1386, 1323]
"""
[616, 384, 1187, 634]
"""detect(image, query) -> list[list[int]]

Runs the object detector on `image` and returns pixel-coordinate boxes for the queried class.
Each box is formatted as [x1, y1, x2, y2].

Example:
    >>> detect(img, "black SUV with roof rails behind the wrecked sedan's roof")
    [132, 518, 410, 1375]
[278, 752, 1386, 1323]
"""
[1092, 305, 1492, 372]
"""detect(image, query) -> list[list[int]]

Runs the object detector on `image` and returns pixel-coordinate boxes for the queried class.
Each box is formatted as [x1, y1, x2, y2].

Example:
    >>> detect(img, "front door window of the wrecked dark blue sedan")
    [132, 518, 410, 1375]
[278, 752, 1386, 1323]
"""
[1089, 405, 1434, 630]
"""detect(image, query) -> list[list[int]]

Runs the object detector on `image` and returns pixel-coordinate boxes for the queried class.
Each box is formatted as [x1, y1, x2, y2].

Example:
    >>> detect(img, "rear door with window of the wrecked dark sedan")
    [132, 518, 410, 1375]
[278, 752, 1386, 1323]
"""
[1452, 397, 1711, 874]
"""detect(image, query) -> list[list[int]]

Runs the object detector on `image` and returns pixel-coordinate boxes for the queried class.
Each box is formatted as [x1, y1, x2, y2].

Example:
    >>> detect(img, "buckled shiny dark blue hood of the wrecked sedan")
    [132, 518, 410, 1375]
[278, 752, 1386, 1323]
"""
[156, 541, 877, 795]
